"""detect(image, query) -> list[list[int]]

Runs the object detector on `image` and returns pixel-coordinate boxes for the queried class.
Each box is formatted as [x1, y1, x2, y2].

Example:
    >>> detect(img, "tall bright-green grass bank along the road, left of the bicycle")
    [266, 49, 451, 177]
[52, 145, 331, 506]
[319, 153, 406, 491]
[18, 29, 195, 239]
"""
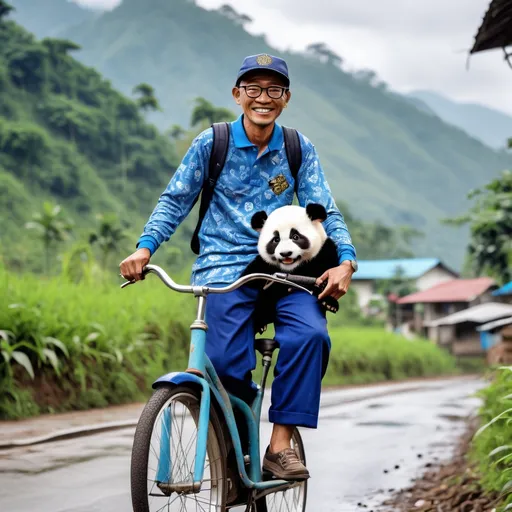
[0, 269, 194, 418]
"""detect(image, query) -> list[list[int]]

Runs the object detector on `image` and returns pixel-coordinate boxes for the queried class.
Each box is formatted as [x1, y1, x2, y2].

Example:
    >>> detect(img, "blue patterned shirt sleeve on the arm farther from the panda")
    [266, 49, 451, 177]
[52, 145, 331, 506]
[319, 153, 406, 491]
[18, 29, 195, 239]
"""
[137, 129, 213, 254]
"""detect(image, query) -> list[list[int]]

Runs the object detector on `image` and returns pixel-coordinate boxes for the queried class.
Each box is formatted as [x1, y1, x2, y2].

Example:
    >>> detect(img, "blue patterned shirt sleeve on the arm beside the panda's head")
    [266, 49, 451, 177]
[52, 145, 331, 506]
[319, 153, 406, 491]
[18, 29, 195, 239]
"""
[297, 138, 356, 263]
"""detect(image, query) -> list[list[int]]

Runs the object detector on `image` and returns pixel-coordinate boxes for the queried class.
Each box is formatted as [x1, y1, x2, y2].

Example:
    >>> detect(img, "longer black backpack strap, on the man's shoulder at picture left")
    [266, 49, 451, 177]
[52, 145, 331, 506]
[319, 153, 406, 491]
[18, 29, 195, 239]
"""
[190, 123, 229, 254]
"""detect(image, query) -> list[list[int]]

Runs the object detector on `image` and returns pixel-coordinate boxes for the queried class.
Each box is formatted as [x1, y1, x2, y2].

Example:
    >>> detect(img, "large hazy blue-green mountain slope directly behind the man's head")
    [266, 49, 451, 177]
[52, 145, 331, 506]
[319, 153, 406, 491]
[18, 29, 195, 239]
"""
[9, 0, 512, 266]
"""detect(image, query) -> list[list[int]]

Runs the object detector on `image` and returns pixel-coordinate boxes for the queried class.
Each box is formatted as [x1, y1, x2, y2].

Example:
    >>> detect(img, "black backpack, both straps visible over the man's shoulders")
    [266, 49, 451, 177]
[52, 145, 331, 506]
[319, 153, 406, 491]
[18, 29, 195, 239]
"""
[190, 123, 302, 254]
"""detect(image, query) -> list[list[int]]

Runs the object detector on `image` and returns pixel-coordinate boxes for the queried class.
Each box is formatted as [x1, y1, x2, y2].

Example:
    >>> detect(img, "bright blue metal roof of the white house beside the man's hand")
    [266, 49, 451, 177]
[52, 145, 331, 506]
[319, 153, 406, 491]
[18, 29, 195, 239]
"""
[352, 258, 441, 280]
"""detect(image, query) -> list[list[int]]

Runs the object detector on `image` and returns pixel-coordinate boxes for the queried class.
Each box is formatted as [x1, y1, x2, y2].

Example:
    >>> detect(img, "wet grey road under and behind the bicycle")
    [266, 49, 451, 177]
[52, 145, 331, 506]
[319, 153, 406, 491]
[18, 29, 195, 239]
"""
[0, 378, 485, 512]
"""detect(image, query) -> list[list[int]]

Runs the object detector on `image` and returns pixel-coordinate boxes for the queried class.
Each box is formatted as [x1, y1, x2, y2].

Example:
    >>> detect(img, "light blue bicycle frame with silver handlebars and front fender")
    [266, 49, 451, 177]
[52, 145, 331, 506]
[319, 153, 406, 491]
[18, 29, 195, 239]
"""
[121, 265, 315, 498]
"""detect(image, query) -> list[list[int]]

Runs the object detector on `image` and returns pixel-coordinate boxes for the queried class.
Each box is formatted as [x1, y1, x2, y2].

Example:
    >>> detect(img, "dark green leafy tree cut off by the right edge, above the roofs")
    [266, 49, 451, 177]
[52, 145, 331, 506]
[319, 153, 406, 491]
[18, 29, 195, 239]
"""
[445, 171, 512, 283]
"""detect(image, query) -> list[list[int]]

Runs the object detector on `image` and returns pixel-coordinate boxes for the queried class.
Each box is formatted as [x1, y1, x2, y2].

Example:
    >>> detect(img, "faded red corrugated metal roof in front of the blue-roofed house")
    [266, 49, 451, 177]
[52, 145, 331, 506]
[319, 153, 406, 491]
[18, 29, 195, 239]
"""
[397, 277, 496, 304]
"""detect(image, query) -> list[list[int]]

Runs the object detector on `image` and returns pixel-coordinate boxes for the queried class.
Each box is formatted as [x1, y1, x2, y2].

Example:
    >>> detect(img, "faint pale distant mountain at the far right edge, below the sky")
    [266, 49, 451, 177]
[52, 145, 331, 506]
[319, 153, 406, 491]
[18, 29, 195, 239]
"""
[409, 91, 512, 148]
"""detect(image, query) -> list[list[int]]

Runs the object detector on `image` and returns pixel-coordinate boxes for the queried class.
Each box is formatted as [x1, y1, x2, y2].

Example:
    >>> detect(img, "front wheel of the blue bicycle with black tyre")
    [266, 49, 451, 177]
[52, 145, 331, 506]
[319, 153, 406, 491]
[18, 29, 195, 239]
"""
[131, 386, 227, 512]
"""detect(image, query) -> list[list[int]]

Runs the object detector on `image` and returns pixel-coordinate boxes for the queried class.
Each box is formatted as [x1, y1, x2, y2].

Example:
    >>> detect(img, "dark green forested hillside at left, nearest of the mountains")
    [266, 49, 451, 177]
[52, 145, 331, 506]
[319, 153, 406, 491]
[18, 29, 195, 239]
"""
[0, 15, 184, 270]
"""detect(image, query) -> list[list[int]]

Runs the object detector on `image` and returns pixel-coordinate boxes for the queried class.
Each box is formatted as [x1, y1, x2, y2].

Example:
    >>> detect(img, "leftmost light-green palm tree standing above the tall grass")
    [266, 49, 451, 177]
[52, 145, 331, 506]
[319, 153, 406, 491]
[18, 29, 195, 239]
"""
[25, 202, 72, 275]
